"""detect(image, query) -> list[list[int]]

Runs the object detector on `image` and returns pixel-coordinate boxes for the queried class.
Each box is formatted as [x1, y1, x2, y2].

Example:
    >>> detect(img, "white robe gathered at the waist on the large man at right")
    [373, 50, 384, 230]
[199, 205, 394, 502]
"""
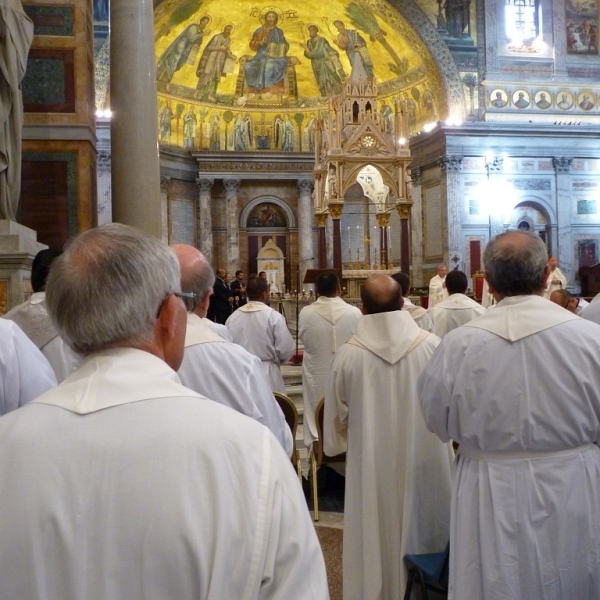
[419, 296, 600, 600]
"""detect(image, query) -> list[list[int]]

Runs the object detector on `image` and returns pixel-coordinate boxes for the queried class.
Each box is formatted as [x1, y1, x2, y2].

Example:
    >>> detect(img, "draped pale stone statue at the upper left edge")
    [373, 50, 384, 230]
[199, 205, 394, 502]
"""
[0, 0, 33, 221]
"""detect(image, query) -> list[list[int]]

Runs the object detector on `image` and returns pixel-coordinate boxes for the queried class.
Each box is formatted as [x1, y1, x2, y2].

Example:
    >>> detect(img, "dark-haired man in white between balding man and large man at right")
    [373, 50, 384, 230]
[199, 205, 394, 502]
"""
[427, 270, 485, 338]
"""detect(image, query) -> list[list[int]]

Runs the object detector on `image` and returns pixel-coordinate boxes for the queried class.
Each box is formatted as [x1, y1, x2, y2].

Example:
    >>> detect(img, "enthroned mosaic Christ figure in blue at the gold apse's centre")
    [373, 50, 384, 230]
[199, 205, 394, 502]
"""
[244, 10, 290, 94]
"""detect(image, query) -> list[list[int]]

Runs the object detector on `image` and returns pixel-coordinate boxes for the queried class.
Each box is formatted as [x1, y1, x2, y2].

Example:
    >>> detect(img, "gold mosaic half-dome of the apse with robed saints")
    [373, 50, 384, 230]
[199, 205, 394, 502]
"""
[154, 0, 447, 152]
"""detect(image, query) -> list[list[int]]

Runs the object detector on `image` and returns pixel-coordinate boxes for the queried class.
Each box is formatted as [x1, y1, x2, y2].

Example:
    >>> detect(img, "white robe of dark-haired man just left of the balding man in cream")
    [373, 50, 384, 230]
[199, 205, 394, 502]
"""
[298, 296, 361, 447]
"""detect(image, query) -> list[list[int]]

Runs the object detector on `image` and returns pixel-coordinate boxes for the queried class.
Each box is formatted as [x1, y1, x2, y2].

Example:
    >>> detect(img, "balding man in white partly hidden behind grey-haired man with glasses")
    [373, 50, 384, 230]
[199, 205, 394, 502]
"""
[171, 244, 293, 456]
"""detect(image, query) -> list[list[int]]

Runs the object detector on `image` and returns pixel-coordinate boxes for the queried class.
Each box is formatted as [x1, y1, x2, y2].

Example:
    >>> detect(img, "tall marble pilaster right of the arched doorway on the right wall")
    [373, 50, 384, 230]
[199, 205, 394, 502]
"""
[548, 156, 576, 285]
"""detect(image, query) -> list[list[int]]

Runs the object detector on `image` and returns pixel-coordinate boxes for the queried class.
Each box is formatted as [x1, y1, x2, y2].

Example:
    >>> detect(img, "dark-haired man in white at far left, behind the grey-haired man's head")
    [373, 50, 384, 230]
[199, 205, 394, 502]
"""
[2, 249, 83, 383]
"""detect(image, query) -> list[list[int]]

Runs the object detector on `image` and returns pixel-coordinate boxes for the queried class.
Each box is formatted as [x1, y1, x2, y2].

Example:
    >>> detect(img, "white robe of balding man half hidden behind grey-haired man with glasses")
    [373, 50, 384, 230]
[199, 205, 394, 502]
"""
[178, 314, 294, 456]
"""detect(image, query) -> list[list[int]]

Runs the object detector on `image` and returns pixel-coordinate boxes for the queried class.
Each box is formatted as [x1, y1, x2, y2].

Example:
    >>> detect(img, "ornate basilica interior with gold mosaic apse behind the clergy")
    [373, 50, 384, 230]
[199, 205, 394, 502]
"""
[0, 0, 600, 314]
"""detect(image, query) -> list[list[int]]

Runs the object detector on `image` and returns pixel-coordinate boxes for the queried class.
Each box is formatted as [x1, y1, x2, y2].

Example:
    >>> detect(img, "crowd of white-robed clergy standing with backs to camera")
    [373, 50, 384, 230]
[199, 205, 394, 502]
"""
[0, 224, 600, 600]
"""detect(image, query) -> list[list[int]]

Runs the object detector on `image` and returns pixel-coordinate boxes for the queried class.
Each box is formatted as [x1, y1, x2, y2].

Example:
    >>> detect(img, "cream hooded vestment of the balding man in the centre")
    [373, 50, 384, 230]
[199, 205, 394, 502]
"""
[324, 311, 453, 600]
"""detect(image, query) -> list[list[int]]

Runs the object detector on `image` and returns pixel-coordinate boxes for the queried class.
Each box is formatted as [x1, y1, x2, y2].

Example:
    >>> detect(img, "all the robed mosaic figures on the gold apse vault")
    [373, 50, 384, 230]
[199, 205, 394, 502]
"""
[156, 9, 435, 152]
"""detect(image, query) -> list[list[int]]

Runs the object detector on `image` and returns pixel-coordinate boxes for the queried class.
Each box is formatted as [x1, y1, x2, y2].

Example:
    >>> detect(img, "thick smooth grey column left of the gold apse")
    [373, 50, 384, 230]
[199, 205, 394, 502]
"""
[110, 0, 162, 238]
